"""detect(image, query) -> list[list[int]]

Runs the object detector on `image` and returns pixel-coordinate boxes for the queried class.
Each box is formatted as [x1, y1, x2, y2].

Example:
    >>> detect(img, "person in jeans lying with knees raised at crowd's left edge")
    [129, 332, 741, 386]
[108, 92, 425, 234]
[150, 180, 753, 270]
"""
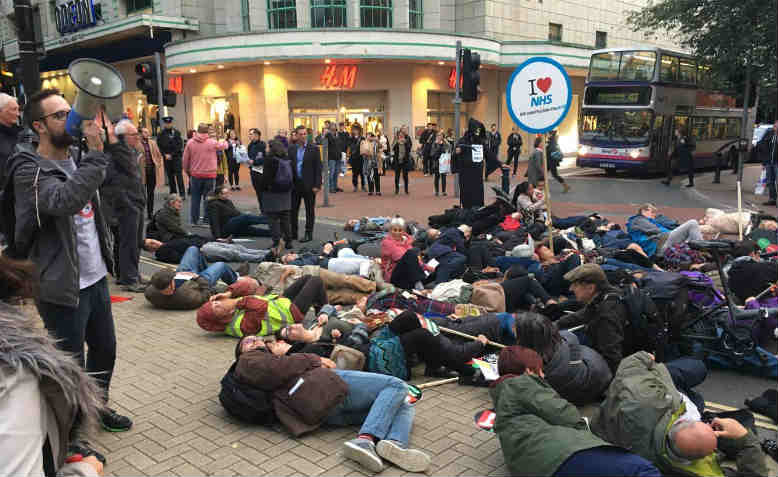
[144, 247, 247, 310]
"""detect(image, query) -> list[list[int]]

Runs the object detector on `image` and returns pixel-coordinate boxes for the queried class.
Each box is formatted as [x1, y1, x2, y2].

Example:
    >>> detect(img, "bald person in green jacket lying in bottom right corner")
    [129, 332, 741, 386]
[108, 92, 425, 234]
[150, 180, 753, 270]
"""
[592, 352, 768, 476]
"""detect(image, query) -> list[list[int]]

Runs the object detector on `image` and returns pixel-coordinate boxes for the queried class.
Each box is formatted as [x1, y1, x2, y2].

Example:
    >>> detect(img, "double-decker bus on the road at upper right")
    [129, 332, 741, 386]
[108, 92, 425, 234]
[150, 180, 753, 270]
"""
[576, 48, 754, 173]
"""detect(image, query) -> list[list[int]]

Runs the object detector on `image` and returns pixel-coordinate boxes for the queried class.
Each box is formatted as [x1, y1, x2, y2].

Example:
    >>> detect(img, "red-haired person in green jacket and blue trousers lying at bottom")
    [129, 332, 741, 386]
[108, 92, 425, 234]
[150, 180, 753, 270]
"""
[489, 346, 661, 477]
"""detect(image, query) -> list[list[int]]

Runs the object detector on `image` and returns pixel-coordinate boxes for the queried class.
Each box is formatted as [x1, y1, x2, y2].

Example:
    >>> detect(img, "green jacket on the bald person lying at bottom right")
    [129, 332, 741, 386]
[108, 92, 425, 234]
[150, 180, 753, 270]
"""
[592, 352, 767, 477]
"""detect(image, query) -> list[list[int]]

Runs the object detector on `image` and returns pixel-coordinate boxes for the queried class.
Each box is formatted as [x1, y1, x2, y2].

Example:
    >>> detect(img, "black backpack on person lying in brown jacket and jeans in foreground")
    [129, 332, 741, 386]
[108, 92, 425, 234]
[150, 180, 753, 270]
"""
[219, 361, 277, 426]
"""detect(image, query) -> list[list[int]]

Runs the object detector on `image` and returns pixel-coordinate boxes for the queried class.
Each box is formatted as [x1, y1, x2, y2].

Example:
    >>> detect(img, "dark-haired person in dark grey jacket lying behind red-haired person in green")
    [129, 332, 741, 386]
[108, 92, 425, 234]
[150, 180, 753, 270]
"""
[516, 313, 613, 405]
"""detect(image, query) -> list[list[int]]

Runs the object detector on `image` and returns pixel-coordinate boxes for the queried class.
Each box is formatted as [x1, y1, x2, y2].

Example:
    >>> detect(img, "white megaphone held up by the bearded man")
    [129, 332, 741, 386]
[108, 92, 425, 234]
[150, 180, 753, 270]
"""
[65, 58, 124, 136]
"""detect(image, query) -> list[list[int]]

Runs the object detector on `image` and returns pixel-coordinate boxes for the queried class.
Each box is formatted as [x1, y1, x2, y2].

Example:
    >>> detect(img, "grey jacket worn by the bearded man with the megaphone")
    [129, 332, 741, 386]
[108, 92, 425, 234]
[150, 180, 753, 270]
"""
[7, 151, 113, 308]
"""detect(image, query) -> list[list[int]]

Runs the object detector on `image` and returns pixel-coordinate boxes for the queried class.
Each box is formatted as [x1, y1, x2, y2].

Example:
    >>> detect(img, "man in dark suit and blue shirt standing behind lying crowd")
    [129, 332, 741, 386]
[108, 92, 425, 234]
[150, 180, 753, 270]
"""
[289, 126, 321, 242]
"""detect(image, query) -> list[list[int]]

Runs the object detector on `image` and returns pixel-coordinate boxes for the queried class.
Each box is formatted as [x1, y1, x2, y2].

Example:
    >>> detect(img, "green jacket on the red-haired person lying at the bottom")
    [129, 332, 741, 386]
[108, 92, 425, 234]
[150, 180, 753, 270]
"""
[490, 374, 610, 475]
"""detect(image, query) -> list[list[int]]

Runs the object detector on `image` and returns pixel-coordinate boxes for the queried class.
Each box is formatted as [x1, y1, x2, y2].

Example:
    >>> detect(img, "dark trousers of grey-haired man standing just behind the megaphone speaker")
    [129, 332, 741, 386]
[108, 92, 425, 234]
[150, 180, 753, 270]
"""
[111, 208, 143, 285]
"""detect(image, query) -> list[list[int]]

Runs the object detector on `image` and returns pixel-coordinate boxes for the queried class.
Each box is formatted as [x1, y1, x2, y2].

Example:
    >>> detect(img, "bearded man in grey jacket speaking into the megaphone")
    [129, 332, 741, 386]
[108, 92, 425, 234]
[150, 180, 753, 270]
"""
[3, 89, 132, 432]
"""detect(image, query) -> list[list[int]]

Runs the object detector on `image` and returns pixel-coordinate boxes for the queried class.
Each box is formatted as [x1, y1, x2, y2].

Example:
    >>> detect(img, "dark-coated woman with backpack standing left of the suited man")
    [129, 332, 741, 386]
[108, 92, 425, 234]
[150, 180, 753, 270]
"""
[262, 140, 293, 251]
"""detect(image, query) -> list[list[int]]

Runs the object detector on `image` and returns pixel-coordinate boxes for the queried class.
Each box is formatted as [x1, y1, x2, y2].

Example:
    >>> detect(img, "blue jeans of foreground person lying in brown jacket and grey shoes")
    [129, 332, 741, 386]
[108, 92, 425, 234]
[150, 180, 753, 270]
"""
[325, 369, 416, 445]
